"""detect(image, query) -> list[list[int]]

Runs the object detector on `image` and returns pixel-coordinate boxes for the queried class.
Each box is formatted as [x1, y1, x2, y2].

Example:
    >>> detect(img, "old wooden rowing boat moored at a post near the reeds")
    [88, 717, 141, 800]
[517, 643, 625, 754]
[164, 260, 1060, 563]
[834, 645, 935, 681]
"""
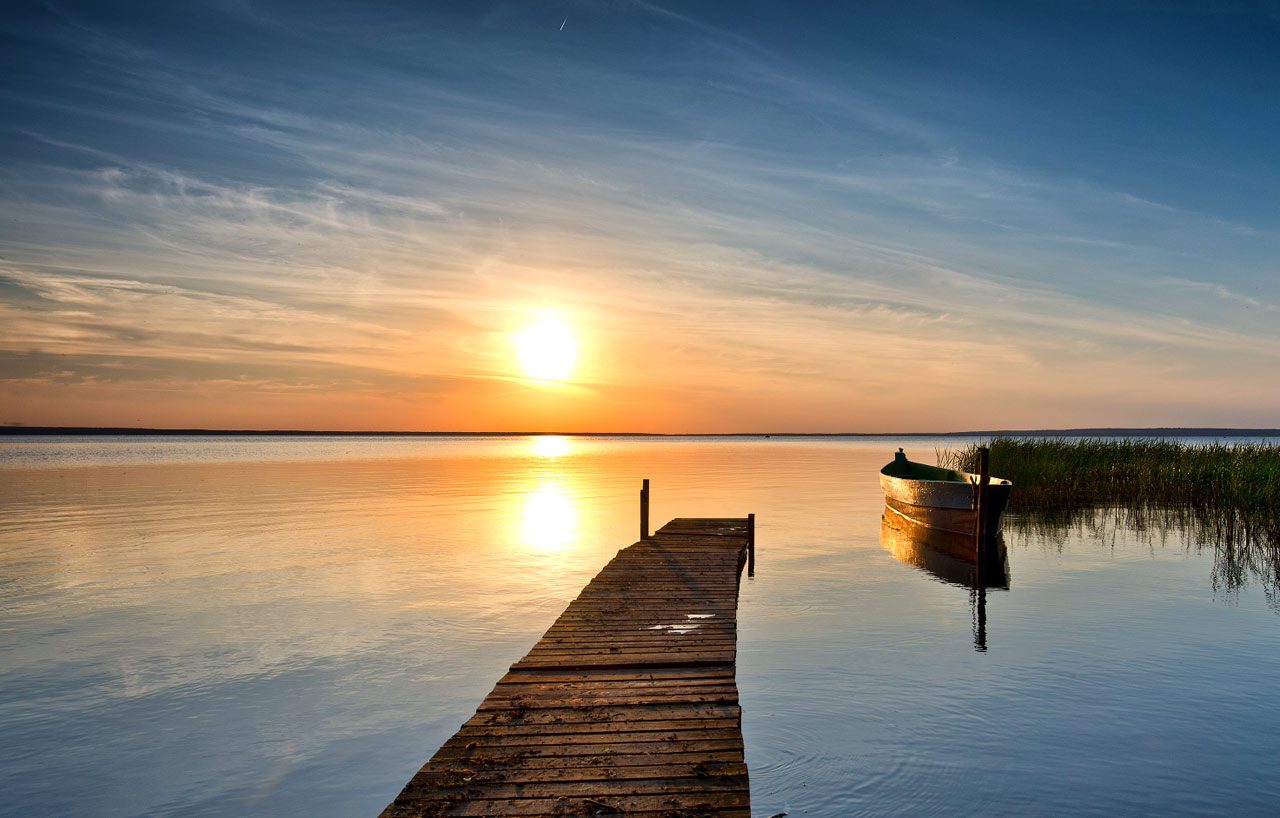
[881, 449, 1014, 536]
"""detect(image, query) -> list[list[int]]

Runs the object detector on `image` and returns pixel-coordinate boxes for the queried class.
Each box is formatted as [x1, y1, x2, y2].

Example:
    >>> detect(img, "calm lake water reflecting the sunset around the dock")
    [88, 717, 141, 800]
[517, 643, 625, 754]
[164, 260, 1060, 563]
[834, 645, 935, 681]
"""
[0, 438, 1280, 817]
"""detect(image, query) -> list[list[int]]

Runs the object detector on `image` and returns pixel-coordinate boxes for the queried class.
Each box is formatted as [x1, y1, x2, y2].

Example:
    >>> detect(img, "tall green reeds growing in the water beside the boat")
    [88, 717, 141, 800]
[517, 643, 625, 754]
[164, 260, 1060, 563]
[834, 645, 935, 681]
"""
[938, 438, 1280, 577]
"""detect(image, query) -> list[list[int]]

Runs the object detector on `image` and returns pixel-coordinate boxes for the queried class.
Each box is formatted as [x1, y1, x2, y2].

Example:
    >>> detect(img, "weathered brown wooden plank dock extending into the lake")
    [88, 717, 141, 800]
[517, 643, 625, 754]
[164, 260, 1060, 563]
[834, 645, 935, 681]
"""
[381, 520, 754, 818]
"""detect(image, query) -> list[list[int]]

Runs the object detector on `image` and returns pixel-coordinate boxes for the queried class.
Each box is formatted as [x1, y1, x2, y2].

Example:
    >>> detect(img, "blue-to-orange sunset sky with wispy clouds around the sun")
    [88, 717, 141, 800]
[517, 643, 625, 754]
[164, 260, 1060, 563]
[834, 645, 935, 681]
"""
[0, 0, 1280, 433]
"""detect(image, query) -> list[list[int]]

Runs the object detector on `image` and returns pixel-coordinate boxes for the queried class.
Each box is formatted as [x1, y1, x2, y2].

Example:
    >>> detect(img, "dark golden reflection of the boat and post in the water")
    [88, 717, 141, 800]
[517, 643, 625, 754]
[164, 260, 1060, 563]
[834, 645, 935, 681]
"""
[881, 506, 1009, 650]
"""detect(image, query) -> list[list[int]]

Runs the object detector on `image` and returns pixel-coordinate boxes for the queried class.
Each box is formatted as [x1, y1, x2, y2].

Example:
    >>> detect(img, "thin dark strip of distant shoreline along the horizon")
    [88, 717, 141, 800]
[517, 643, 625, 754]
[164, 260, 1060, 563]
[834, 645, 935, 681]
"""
[0, 425, 1280, 438]
